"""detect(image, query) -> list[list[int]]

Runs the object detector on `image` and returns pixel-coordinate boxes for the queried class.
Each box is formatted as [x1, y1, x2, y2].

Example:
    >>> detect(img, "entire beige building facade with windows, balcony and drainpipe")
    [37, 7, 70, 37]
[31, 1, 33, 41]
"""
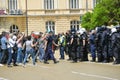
[0, 0, 96, 34]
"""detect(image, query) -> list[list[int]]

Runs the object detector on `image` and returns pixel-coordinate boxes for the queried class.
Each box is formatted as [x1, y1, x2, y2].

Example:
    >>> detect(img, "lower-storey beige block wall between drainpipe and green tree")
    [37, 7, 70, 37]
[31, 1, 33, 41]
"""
[28, 16, 80, 34]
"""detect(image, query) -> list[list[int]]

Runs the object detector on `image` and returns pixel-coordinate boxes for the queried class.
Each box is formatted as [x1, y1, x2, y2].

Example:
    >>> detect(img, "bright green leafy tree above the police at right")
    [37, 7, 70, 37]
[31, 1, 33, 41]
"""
[82, 0, 120, 30]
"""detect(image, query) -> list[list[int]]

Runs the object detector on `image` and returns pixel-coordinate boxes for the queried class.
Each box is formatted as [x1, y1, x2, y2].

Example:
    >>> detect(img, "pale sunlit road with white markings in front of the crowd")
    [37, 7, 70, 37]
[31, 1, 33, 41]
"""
[0, 51, 120, 80]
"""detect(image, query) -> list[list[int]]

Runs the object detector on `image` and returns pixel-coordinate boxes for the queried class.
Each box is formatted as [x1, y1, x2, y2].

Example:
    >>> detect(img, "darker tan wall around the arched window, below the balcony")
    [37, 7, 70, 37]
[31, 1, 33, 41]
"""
[0, 17, 26, 33]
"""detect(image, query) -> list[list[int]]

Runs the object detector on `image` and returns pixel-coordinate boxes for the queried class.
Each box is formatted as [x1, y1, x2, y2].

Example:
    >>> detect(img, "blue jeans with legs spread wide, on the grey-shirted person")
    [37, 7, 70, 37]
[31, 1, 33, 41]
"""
[23, 49, 35, 65]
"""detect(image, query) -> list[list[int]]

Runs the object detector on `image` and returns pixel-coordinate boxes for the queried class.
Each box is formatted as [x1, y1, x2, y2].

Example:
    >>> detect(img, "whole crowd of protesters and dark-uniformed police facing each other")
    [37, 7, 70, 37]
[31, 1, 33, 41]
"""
[0, 26, 120, 67]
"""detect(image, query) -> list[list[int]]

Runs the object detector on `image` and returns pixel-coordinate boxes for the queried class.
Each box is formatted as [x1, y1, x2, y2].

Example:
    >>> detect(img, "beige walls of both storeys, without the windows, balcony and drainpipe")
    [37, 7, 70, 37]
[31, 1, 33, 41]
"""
[0, 0, 93, 34]
